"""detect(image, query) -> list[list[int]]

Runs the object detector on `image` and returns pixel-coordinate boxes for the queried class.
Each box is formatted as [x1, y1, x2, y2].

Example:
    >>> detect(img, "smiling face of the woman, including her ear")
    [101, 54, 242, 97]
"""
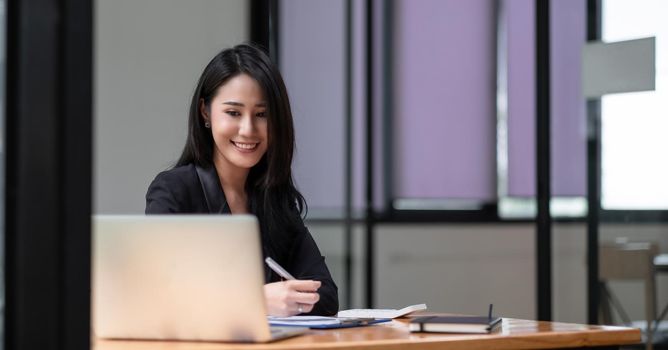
[200, 74, 269, 174]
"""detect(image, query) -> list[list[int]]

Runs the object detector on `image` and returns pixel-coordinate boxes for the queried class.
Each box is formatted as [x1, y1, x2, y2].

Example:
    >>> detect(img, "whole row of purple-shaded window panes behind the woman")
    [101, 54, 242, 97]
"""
[279, 0, 586, 218]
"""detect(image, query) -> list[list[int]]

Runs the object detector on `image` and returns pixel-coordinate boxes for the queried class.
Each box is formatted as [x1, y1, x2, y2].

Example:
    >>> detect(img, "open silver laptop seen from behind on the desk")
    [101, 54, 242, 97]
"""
[92, 215, 305, 342]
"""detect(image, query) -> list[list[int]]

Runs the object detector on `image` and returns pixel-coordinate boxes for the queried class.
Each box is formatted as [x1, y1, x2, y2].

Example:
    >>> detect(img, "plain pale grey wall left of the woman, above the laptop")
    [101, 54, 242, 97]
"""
[93, 0, 249, 213]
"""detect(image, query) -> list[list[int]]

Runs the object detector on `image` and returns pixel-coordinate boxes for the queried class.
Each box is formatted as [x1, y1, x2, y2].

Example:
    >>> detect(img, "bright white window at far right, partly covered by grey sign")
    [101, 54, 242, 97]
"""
[601, 0, 668, 210]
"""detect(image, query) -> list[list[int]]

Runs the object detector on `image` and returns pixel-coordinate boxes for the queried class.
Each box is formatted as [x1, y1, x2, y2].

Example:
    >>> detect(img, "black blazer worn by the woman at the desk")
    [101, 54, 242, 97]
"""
[146, 164, 339, 315]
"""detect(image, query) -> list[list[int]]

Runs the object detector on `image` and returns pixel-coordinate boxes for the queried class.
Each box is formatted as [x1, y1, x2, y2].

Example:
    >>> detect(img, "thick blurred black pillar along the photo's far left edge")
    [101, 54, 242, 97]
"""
[4, 0, 92, 349]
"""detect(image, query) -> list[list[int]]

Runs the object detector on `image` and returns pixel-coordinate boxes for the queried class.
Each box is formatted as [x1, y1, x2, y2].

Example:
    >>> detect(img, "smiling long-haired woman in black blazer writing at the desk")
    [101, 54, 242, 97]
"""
[146, 45, 338, 316]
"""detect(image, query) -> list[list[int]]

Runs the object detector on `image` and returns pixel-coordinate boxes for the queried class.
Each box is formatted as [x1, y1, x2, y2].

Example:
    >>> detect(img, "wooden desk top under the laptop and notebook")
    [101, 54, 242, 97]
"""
[93, 318, 640, 350]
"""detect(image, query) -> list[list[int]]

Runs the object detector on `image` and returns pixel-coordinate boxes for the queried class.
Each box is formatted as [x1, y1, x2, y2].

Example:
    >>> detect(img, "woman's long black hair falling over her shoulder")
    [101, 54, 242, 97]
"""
[176, 44, 307, 259]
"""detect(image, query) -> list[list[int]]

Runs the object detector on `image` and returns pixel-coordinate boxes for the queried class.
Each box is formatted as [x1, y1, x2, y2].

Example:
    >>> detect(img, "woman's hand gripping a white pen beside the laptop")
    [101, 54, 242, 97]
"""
[264, 280, 320, 317]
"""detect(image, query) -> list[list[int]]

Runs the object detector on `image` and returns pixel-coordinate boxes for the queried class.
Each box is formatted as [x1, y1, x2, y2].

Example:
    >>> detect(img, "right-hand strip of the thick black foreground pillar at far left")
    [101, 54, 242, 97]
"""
[59, 0, 93, 349]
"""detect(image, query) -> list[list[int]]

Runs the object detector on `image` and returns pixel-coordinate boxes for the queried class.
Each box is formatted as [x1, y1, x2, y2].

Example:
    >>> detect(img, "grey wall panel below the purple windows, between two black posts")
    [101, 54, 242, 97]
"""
[376, 225, 535, 318]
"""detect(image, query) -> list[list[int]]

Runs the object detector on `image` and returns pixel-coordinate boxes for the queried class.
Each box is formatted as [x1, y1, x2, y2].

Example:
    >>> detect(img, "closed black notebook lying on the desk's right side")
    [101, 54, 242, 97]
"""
[408, 316, 501, 334]
